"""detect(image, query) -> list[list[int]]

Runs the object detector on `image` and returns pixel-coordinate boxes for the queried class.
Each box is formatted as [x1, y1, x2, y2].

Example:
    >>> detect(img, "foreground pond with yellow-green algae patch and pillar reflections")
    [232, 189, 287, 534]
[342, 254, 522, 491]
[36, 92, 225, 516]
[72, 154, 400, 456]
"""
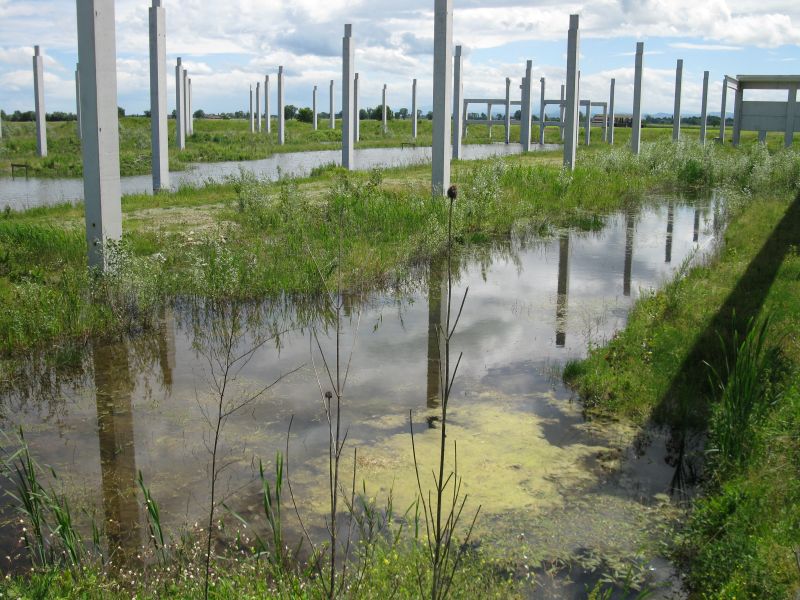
[0, 198, 719, 597]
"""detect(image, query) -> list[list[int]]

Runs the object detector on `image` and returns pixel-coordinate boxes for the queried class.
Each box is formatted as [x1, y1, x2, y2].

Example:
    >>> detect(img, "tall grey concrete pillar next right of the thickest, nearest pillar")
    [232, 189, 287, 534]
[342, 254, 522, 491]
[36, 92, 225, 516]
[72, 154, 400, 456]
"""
[149, 0, 169, 193]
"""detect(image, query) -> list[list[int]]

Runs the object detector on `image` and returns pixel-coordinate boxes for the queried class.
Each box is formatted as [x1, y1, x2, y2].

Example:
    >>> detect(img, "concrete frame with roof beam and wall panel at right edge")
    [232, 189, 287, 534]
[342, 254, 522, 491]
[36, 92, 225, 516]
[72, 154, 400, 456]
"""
[720, 75, 800, 148]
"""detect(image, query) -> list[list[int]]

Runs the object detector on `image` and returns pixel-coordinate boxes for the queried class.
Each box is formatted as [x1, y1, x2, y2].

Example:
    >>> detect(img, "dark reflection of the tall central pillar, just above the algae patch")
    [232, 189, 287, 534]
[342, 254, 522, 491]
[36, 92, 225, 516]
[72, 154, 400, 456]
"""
[427, 256, 447, 408]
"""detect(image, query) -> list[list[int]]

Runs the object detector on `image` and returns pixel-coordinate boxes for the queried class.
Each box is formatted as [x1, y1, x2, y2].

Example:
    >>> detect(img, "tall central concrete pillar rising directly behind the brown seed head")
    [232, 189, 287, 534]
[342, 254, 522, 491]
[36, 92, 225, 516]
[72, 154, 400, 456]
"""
[431, 0, 453, 196]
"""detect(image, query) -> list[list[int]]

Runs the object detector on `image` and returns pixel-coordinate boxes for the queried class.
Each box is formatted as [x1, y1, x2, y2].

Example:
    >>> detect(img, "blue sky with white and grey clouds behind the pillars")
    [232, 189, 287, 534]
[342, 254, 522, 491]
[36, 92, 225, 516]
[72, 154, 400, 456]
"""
[0, 0, 800, 115]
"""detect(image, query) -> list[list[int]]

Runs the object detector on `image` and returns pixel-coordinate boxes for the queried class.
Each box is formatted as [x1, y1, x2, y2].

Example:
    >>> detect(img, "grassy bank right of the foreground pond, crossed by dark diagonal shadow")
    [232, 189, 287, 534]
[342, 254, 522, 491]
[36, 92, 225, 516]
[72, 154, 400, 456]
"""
[565, 144, 800, 599]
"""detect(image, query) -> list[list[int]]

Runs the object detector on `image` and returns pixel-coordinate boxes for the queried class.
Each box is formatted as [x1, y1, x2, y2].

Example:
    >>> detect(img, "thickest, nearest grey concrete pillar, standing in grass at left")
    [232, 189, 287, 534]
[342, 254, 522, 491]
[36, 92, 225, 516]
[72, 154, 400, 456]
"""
[76, 0, 122, 270]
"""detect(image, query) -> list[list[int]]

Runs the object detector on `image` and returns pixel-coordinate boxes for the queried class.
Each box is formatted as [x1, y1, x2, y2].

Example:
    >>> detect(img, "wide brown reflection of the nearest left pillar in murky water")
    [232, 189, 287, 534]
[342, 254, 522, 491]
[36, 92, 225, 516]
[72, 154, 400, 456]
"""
[92, 343, 140, 563]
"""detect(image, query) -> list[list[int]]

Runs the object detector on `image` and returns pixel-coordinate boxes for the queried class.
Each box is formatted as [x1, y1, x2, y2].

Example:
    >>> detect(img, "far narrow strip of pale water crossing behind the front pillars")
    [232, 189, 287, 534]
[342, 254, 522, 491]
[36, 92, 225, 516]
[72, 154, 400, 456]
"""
[0, 144, 560, 210]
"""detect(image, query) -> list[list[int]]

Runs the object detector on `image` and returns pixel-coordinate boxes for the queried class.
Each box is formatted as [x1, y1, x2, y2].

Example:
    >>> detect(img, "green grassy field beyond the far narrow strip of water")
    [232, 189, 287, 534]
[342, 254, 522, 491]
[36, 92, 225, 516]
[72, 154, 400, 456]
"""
[0, 112, 800, 177]
